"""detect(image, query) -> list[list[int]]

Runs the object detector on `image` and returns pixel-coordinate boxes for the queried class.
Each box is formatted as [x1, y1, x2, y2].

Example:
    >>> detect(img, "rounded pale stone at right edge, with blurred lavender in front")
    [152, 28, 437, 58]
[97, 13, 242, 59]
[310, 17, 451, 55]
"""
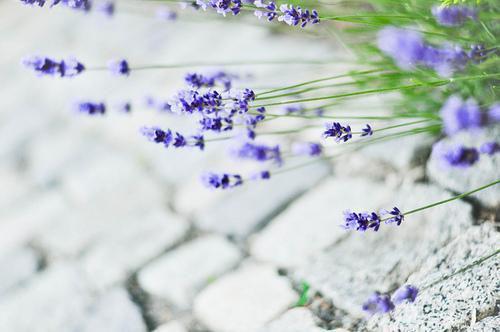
[427, 125, 500, 207]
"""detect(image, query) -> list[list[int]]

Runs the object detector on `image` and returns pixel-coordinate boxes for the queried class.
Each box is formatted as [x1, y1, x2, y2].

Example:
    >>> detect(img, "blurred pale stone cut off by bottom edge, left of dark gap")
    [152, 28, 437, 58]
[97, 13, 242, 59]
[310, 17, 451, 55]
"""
[79, 288, 147, 332]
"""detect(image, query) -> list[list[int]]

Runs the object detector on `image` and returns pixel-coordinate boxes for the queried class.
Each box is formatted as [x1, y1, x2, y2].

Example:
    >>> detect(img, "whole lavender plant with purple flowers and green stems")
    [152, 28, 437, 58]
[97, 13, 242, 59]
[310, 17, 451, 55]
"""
[21, 0, 500, 320]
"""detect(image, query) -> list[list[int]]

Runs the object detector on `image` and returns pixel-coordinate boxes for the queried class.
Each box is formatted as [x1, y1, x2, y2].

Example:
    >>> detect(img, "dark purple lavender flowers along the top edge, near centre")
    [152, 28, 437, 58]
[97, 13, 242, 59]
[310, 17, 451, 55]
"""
[194, 0, 320, 28]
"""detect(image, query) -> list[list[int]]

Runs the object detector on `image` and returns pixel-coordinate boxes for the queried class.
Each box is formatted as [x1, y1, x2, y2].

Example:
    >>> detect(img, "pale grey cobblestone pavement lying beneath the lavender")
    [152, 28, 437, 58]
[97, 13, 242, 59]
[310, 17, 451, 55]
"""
[0, 1, 500, 332]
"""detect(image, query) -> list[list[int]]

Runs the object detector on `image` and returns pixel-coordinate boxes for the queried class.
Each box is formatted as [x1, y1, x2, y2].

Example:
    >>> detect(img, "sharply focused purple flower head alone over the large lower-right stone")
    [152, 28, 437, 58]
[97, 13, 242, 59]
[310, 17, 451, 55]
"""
[344, 207, 404, 232]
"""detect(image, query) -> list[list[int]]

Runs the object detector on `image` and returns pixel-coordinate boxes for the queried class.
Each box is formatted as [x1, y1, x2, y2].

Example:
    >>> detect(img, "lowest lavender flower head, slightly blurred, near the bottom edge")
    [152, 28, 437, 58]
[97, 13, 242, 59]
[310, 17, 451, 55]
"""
[362, 285, 418, 315]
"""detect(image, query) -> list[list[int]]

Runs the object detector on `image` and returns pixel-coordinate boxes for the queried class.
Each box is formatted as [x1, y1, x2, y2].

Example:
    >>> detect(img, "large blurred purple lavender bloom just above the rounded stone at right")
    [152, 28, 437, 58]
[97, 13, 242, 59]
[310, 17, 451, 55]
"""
[440, 95, 481, 135]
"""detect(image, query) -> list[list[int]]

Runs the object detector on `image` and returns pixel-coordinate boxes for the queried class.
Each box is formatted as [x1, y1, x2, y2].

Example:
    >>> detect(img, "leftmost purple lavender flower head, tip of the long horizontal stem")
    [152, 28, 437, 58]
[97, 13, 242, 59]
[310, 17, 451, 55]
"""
[23, 56, 85, 77]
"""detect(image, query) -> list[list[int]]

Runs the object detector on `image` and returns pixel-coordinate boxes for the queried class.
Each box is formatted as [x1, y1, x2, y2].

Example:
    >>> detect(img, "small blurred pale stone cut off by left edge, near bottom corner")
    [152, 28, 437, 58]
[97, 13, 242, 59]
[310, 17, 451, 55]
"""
[0, 248, 38, 296]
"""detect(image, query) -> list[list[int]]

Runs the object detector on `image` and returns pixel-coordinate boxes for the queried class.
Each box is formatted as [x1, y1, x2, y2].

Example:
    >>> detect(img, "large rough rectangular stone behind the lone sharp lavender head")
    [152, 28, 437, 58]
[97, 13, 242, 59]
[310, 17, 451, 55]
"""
[295, 185, 472, 317]
